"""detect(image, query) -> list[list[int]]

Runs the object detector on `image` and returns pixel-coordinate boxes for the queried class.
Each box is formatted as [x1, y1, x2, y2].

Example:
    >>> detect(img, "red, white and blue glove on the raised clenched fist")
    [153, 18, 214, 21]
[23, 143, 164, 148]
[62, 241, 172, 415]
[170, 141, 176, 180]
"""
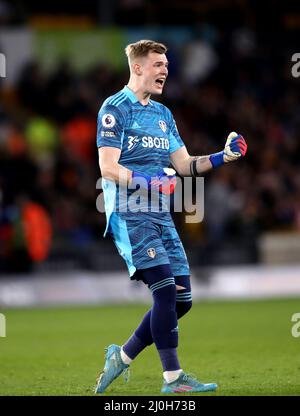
[209, 131, 248, 168]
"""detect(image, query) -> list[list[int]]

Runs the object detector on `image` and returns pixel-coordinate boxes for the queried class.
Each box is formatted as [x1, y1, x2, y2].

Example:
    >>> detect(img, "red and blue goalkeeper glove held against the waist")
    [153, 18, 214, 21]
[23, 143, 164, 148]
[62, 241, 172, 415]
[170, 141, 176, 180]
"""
[132, 168, 176, 195]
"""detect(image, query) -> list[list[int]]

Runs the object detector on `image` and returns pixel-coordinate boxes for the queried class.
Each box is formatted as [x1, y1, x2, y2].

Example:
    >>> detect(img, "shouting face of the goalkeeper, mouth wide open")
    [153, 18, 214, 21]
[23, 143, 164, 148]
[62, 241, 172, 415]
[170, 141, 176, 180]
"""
[140, 52, 168, 94]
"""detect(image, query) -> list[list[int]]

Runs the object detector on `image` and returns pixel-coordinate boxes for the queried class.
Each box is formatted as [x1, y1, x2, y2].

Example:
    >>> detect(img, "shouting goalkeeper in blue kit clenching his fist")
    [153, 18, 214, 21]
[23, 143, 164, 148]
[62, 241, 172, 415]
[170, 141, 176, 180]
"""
[96, 40, 247, 393]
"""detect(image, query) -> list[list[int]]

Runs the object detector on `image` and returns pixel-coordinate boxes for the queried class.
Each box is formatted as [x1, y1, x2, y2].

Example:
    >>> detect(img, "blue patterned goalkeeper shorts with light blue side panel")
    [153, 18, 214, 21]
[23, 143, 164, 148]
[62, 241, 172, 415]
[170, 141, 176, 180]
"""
[109, 214, 190, 280]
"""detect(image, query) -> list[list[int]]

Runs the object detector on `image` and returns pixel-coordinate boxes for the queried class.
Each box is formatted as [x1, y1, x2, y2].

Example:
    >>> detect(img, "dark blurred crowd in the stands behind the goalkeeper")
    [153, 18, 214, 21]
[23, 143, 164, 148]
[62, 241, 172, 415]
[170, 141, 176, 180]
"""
[0, 0, 300, 272]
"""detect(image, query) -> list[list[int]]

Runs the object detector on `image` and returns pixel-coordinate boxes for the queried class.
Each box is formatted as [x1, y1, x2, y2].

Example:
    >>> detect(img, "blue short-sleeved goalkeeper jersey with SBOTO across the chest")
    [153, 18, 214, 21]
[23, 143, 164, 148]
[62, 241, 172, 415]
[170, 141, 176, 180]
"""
[97, 86, 184, 233]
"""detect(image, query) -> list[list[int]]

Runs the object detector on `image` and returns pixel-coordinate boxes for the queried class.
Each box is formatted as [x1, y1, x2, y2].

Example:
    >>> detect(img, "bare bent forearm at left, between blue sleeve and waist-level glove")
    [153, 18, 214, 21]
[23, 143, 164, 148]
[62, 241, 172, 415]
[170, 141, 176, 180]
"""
[98, 146, 132, 185]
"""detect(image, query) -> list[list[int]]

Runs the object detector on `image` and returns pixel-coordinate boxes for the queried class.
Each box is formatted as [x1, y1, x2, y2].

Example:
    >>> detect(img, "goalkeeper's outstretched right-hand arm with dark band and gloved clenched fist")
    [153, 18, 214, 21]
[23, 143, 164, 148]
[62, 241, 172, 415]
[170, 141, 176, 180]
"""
[170, 132, 247, 176]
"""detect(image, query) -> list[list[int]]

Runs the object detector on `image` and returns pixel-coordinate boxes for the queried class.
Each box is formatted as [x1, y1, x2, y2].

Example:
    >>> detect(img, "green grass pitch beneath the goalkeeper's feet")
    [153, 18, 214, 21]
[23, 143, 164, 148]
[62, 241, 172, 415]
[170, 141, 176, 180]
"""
[0, 299, 300, 396]
